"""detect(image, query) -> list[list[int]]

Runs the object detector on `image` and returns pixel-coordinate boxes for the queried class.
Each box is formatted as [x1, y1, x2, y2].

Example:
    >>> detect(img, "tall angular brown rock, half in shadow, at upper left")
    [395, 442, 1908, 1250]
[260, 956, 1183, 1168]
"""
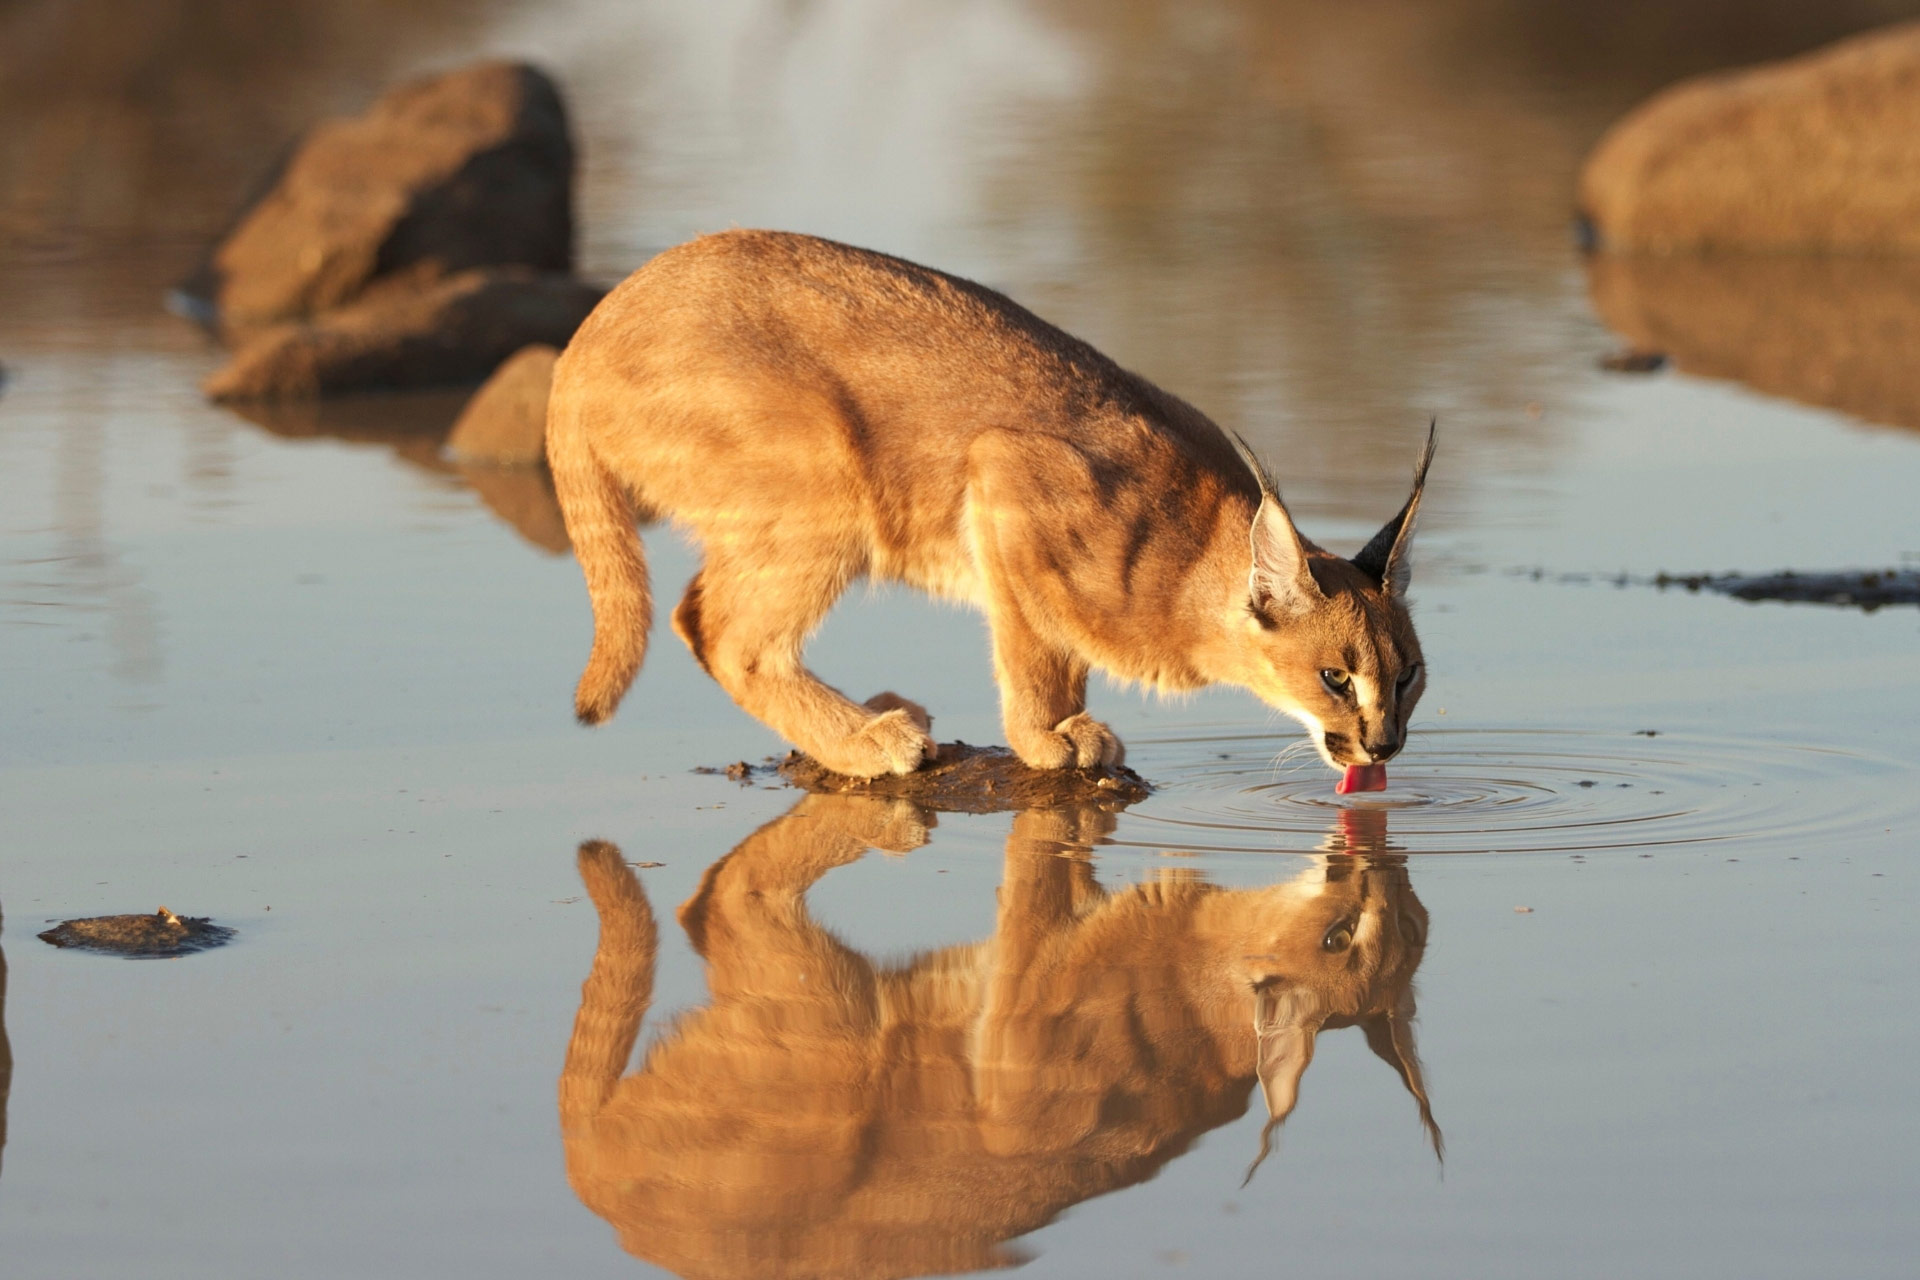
[182, 61, 574, 324]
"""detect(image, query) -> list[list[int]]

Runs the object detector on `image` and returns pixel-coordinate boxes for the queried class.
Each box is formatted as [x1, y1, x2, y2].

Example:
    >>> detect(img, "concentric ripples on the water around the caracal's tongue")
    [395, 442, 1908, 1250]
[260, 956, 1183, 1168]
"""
[1116, 729, 1920, 854]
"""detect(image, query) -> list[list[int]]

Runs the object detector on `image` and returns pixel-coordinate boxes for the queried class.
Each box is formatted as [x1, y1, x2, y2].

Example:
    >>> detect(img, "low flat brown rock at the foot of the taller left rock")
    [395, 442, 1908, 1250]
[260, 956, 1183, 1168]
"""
[202, 267, 601, 399]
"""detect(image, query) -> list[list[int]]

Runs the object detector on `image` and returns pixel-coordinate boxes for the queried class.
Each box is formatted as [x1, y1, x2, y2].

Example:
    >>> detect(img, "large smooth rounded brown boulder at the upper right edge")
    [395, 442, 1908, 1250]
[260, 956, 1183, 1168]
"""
[1578, 23, 1920, 253]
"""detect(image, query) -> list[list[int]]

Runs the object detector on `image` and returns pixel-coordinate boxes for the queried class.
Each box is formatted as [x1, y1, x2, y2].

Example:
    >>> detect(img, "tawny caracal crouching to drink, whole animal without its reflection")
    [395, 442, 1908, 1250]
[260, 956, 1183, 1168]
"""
[547, 232, 1432, 785]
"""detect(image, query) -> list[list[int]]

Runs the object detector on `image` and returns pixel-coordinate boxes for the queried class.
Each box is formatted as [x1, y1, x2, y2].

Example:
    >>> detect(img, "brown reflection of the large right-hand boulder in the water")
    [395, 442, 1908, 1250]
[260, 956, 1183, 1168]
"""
[1588, 255, 1920, 428]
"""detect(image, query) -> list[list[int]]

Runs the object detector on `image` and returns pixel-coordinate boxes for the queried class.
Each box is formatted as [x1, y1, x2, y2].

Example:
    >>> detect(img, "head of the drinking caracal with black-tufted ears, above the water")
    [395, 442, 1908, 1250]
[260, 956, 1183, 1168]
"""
[1236, 428, 1434, 771]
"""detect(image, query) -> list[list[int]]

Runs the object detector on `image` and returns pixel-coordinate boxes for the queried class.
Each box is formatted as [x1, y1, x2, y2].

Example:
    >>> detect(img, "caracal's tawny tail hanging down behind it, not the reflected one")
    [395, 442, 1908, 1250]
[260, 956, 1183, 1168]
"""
[547, 372, 653, 725]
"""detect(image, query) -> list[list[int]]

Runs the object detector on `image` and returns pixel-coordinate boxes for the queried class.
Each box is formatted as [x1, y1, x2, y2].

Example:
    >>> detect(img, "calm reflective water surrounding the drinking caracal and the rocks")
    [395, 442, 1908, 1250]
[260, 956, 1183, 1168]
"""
[0, 0, 1920, 1276]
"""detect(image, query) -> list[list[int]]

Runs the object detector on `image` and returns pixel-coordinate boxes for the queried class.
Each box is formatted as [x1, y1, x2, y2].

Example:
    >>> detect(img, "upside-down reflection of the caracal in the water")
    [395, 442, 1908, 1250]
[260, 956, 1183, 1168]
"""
[561, 794, 1440, 1280]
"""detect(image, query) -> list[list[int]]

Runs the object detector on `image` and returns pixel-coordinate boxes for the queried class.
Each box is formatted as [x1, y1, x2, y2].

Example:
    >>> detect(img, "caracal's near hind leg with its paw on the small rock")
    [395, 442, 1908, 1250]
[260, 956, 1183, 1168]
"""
[674, 535, 933, 777]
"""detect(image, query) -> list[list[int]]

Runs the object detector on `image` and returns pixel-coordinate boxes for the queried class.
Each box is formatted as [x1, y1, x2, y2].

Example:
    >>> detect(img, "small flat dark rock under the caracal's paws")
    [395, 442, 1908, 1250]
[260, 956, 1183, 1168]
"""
[780, 743, 1150, 814]
